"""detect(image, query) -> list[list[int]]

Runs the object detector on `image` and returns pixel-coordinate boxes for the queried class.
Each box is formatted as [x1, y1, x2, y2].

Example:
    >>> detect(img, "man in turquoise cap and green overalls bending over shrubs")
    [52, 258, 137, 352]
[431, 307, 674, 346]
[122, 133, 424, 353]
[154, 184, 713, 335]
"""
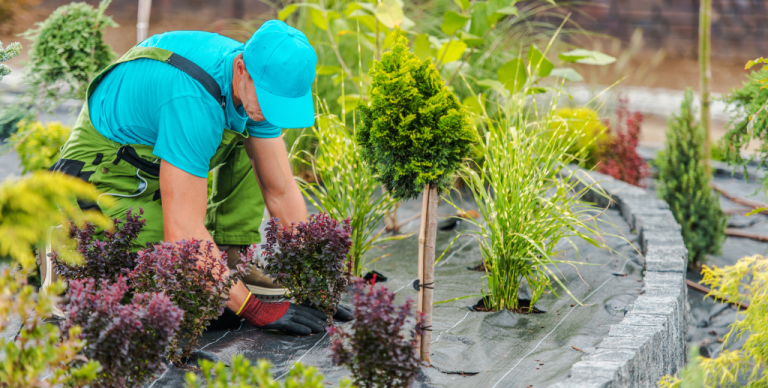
[52, 20, 340, 335]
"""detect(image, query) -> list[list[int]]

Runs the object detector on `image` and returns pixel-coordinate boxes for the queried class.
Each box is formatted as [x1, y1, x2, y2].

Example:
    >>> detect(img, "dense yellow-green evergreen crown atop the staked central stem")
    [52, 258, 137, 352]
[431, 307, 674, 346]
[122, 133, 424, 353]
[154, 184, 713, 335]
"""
[356, 29, 477, 199]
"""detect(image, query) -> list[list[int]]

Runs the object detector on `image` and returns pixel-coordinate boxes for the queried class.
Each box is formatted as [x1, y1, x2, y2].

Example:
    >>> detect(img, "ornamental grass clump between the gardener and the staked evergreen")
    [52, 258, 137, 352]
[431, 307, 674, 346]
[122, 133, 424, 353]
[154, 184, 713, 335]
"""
[294, 113, 409, 277]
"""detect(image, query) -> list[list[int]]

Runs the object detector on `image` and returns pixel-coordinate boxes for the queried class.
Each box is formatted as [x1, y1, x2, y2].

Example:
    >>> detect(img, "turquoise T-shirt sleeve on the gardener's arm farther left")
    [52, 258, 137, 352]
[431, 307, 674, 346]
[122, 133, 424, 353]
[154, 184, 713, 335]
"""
[154, 95, 224, 178]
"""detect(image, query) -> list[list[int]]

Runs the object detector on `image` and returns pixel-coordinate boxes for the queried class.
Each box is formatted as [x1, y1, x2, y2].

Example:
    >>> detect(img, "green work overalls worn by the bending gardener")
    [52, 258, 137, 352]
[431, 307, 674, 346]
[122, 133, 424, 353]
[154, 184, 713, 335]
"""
[51, 47, 264, 247]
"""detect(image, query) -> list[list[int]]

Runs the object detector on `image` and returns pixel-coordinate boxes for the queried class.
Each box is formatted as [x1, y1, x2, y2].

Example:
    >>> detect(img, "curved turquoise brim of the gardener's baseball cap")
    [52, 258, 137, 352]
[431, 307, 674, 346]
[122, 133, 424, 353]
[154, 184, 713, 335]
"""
[254, 85, 315, 128]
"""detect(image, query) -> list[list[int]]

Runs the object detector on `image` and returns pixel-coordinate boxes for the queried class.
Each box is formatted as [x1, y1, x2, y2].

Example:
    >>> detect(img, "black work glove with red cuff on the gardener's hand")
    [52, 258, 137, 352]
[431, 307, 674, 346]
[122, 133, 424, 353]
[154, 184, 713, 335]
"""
[237, 294, 328, 335]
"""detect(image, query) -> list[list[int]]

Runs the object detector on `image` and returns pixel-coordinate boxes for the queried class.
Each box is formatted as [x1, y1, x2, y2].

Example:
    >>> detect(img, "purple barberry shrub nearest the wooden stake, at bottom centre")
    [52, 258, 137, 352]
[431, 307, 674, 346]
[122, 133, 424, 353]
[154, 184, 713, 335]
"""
[326, 279, 423, 388]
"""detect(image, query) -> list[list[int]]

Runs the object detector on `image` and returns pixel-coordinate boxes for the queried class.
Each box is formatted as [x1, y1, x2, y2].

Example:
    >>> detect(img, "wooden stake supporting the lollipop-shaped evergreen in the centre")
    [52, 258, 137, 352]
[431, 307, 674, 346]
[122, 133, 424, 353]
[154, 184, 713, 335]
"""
[420, 184, 437, 363]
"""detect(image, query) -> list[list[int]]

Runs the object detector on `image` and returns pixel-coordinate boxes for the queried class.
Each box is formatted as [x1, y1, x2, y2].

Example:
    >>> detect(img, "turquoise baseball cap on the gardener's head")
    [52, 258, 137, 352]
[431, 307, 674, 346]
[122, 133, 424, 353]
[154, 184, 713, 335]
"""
[243, 20, 317, 128]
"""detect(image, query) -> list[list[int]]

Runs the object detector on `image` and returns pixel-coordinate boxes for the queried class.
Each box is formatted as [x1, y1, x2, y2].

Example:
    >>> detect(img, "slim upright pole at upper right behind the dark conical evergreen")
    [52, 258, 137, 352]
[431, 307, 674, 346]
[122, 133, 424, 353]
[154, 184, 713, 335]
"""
[699, 0, 712, 175]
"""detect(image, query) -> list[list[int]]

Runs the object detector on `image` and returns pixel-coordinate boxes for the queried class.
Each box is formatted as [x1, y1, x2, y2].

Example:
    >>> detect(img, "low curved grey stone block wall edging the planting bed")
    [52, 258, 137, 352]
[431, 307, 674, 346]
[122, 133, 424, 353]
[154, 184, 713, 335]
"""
[552, 169, 690, 388]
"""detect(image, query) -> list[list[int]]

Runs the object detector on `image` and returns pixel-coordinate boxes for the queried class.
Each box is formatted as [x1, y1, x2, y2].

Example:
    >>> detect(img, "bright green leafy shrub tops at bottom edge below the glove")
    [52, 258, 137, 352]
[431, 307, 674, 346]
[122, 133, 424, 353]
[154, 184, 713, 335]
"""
[185, 354, 351, 388]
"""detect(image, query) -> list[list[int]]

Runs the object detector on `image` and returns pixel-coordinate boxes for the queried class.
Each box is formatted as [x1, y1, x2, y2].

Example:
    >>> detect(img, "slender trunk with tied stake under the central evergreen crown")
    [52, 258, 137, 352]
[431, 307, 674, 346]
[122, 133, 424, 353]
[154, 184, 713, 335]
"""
[416, 184, 437, 363]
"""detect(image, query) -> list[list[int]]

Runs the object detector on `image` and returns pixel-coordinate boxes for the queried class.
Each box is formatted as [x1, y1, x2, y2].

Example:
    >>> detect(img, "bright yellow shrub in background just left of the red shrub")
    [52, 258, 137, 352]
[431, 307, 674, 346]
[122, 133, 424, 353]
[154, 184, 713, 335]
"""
[550, 108, 607, 168]
